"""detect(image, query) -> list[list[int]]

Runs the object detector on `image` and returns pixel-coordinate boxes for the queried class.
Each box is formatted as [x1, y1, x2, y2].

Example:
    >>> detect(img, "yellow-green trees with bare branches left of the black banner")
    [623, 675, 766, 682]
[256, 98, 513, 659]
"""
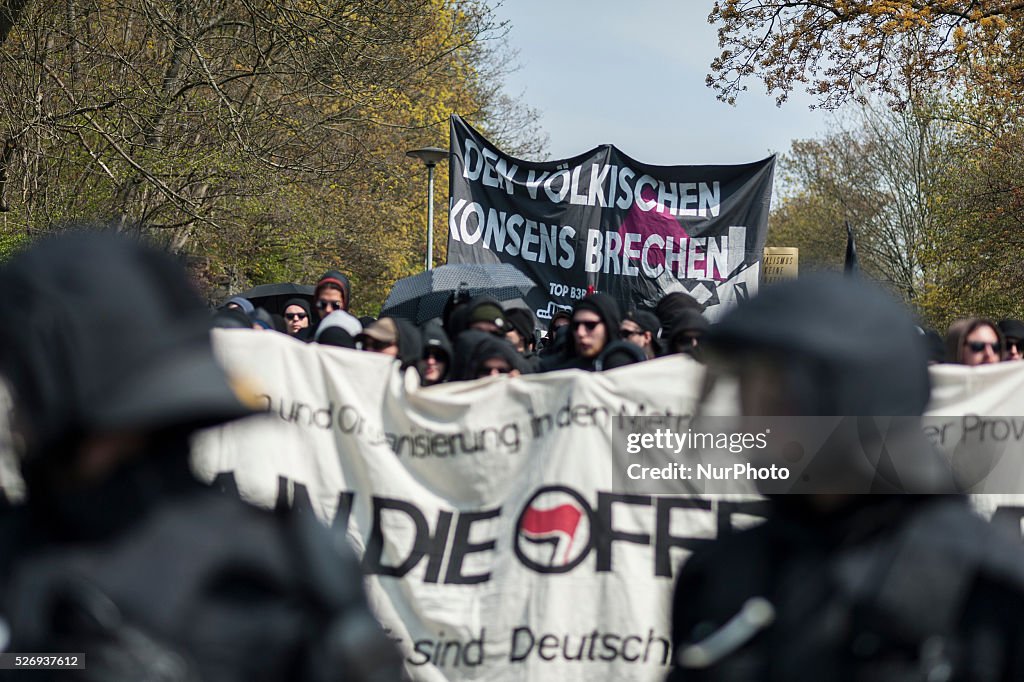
[0, 0, 538, 311]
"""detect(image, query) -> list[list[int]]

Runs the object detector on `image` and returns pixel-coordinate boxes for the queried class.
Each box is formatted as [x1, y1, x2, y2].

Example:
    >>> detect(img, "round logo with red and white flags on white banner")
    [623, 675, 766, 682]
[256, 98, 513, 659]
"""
[515, 485, 593, 573]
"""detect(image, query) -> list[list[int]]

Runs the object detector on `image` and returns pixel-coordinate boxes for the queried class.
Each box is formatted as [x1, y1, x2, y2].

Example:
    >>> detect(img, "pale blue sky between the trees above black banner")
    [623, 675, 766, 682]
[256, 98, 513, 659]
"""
[492, 0, 827, 165]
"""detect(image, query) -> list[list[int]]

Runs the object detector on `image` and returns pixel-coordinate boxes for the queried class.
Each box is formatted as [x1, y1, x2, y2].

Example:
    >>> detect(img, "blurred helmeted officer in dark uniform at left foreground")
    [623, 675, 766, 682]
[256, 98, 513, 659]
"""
[0, 233, 398, 682]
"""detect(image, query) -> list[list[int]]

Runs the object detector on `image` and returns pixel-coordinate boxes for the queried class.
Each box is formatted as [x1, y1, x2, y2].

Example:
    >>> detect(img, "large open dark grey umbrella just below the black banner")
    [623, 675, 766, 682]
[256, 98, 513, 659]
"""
[381, 263, 537, 324]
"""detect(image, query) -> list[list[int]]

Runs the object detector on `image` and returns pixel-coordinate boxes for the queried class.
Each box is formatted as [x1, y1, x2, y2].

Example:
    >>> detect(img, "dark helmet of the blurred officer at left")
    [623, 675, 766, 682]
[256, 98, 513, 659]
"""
[0, 232, 252, 457]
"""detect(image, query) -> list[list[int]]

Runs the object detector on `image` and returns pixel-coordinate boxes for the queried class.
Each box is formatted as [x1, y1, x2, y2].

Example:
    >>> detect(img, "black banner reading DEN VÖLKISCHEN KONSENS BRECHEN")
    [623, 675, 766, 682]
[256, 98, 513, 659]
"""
[447, 116, 775, 325]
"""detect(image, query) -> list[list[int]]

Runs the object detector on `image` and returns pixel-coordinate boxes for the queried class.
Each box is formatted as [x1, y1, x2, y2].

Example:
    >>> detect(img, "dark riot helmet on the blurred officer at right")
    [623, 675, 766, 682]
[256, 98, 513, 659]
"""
[708, 273, 930, 416]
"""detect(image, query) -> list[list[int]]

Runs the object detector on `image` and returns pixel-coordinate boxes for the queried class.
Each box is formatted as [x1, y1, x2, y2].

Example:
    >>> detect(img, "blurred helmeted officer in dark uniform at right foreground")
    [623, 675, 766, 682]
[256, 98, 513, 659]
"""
[670, 275, 1024, 682]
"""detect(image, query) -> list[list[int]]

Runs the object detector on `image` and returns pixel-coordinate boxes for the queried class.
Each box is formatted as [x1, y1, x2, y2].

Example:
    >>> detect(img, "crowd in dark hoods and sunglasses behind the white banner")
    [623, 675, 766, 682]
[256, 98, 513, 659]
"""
[214, 270, 1024, 378]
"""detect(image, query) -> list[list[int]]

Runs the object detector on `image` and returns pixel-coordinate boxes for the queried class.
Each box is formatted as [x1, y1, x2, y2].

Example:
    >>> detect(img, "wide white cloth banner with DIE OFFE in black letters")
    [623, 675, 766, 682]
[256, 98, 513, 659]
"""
[196, 331, 744, 680]
